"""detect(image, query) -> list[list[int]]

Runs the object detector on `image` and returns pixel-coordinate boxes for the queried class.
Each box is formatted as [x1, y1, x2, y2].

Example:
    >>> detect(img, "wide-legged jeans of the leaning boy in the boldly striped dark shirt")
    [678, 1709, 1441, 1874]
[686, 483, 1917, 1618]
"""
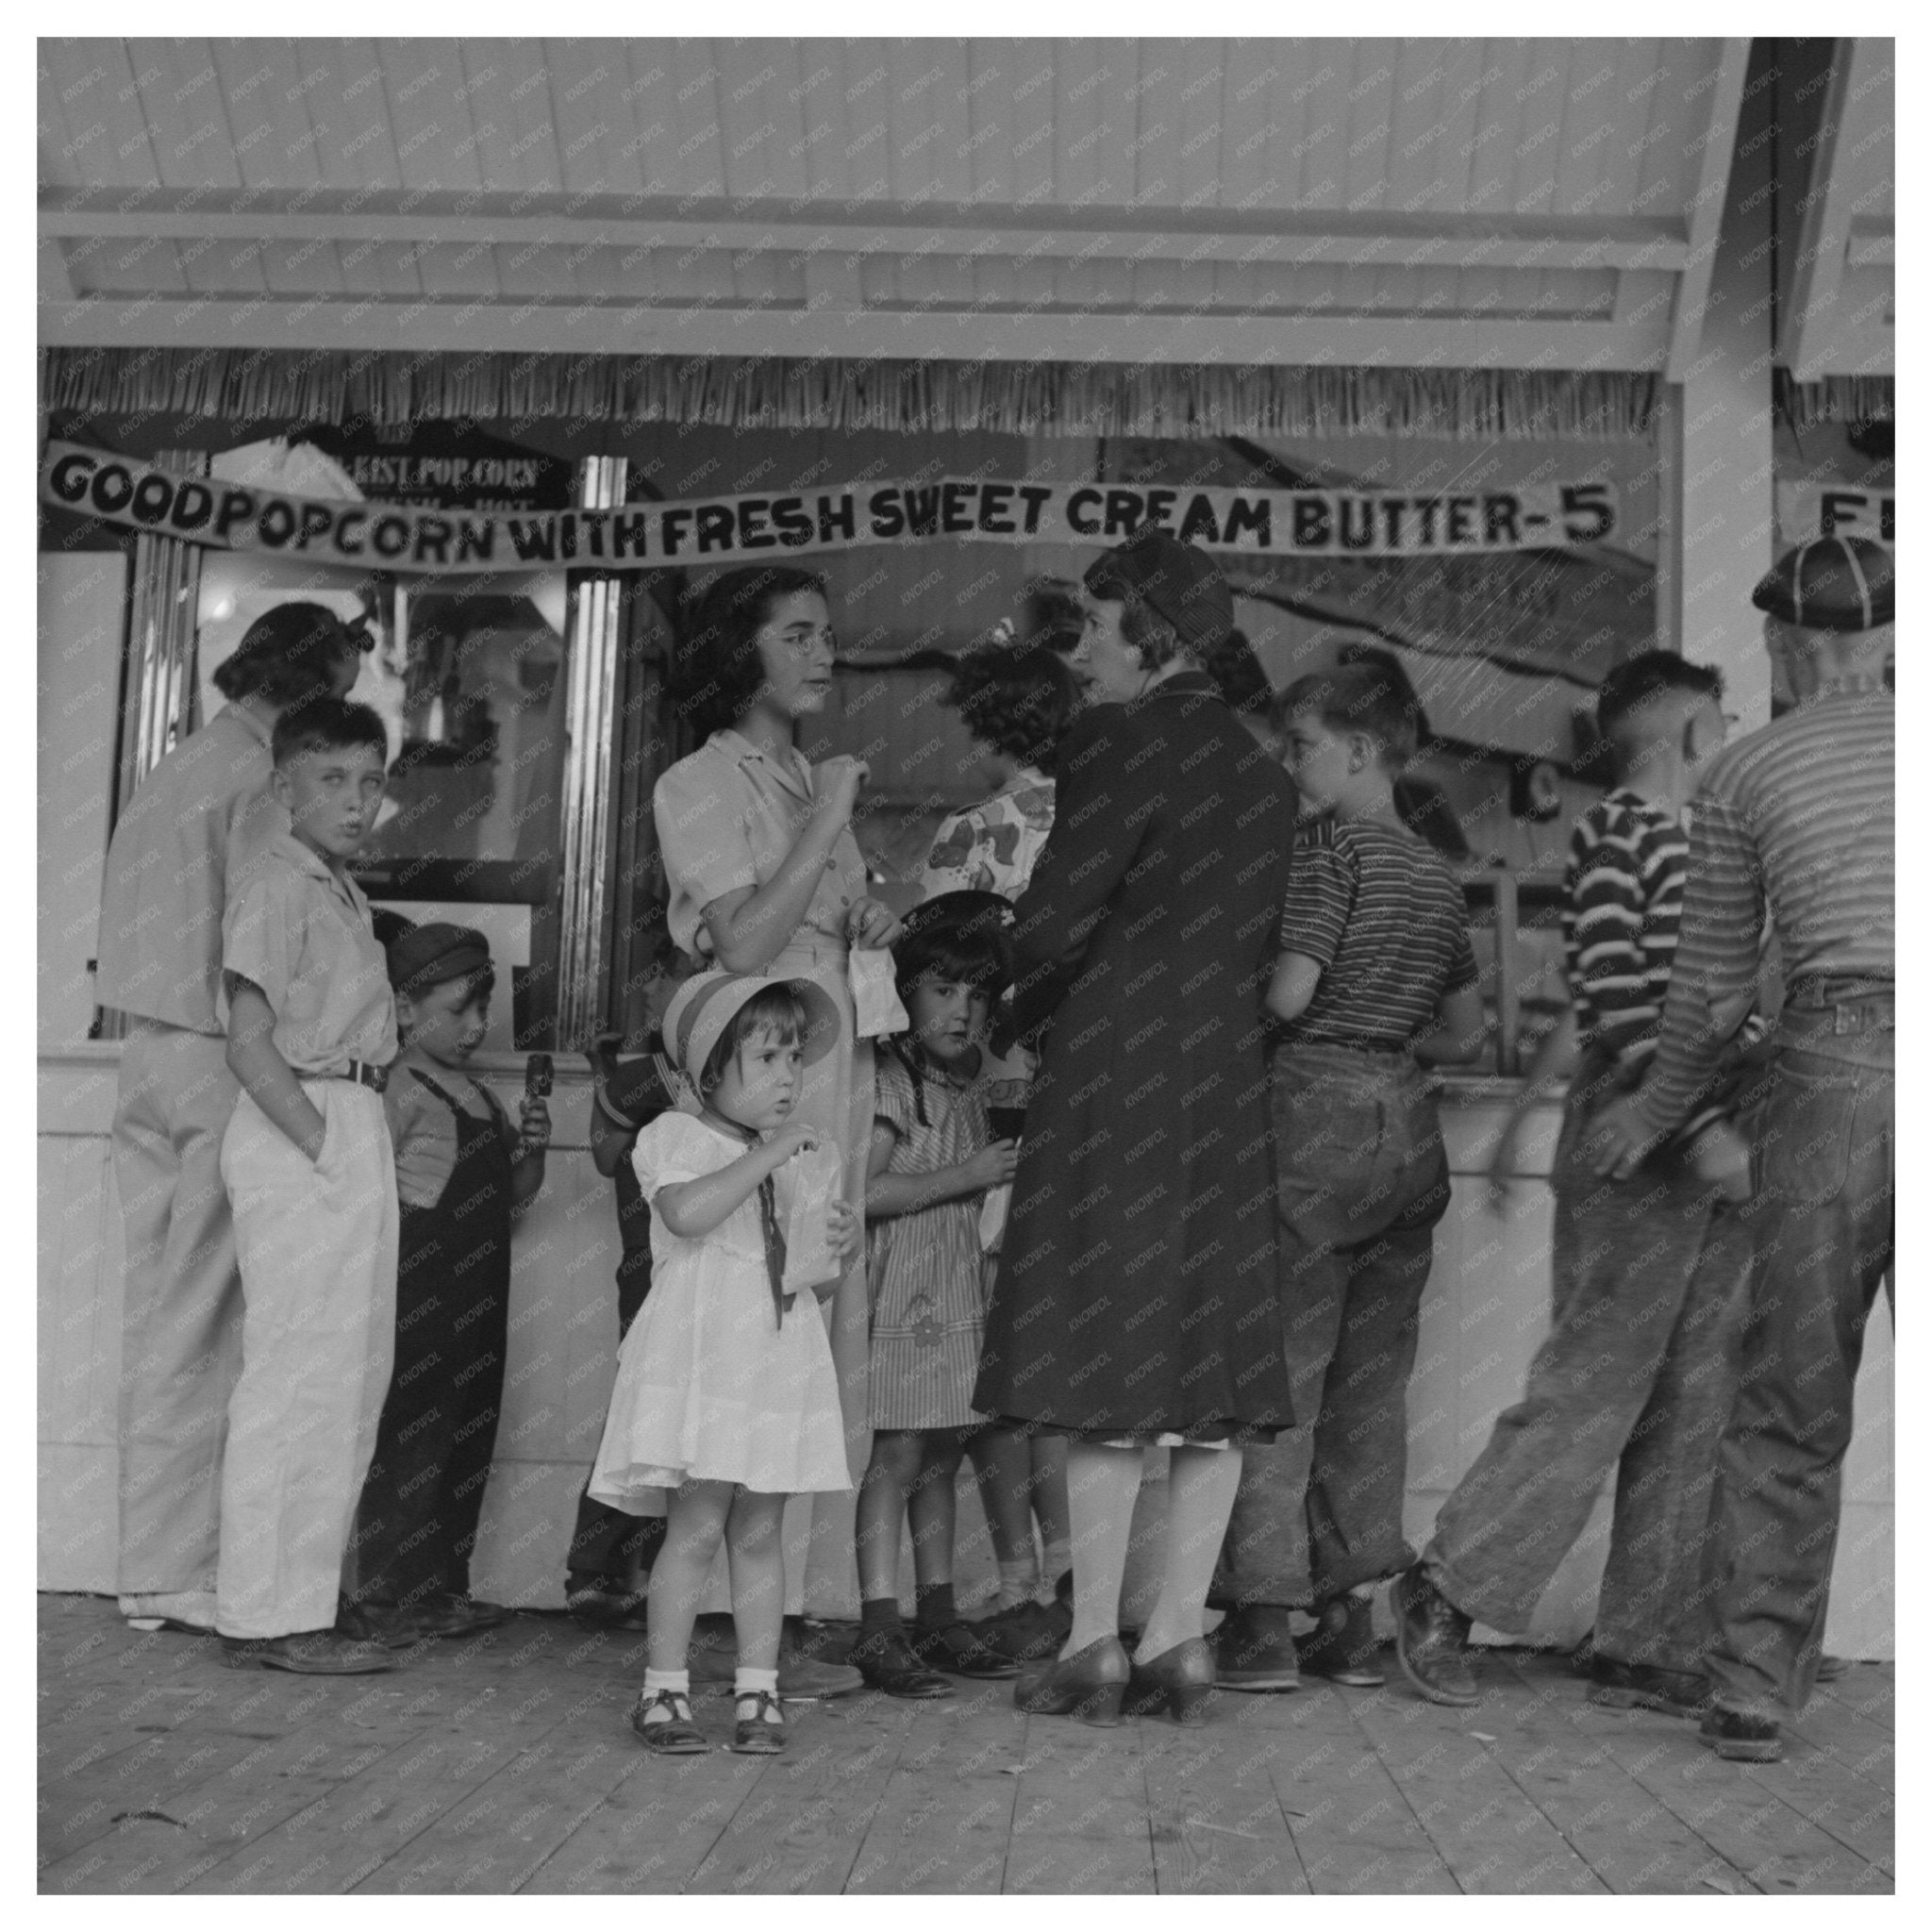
[1424, 1055, 1750, 1672]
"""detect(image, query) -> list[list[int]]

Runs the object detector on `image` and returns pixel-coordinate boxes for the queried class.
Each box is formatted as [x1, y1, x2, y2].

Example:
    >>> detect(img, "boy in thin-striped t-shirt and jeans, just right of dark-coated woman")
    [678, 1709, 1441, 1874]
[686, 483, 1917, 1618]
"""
[1215, 665, 1484, 1690]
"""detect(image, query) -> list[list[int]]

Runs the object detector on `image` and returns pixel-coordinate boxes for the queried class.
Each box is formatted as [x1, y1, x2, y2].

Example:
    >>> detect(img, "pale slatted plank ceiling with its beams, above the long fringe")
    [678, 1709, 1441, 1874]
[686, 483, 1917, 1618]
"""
[41, 39, 1769, 367]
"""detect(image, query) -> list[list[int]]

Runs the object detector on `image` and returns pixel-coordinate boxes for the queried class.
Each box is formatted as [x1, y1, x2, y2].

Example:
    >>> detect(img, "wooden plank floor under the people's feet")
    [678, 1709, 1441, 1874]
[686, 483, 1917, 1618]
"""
[39, 1596, 1893, 1897]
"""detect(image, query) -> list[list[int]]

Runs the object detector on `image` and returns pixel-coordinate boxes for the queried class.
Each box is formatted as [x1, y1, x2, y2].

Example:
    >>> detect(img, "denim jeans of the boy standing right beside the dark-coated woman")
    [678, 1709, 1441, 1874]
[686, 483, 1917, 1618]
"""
[1211, 1045, 1449, 1607]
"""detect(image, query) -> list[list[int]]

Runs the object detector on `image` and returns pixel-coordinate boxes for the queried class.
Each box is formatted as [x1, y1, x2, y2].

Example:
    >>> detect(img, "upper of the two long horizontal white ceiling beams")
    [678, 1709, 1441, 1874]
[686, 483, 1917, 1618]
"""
[39, 190, 1690, 269]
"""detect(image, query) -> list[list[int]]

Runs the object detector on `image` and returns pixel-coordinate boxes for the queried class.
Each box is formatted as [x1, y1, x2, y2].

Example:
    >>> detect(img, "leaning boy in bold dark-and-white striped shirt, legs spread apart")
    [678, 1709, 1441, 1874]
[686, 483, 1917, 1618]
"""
[1395, 651, 1748, 1712]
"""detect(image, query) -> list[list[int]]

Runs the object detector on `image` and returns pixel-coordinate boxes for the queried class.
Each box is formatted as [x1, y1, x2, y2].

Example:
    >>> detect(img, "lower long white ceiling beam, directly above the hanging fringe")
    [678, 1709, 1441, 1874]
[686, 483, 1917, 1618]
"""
[39, 295, 1665, 369]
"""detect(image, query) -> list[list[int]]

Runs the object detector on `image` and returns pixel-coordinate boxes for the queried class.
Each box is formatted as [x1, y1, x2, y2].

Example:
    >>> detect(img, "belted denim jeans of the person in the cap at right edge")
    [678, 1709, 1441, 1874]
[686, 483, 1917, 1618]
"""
[1707, 1003, 1893, 1718]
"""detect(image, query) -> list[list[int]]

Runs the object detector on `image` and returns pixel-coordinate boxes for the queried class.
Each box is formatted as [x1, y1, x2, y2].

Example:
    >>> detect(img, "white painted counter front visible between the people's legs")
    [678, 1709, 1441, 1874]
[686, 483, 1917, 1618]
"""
[39, 1049, 1893, 1657]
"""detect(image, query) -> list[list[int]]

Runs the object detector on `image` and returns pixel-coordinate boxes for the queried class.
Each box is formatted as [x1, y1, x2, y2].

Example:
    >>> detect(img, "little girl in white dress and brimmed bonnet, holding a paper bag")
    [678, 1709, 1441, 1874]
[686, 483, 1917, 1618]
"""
[590, 972, 859, 1753]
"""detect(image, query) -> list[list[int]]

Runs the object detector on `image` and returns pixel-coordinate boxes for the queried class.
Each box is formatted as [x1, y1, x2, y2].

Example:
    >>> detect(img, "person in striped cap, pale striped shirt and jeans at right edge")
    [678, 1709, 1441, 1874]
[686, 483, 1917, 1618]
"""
[1596, 537, 1893, 1762]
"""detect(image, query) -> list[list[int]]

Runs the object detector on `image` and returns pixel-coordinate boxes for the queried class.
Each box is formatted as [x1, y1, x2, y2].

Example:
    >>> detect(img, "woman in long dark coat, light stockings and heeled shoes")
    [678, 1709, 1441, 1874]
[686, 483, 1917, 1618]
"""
[974, 531, 1294, 1722]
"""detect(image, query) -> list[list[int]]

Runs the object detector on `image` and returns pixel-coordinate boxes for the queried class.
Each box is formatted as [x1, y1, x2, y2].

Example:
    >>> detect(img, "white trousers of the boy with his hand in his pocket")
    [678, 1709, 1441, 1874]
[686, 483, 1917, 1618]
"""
[216, 1080, 396, 1637]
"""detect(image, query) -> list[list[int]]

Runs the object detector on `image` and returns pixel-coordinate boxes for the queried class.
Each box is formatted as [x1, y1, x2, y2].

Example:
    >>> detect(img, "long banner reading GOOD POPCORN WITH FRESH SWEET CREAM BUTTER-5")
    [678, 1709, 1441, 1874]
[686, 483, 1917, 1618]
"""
[41, 442, 1617, 575]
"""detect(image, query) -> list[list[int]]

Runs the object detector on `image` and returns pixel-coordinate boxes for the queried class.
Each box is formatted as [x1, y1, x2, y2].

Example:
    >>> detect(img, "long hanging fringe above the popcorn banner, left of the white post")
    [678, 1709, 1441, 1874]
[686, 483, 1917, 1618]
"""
[41, 348, 1661, 442]
